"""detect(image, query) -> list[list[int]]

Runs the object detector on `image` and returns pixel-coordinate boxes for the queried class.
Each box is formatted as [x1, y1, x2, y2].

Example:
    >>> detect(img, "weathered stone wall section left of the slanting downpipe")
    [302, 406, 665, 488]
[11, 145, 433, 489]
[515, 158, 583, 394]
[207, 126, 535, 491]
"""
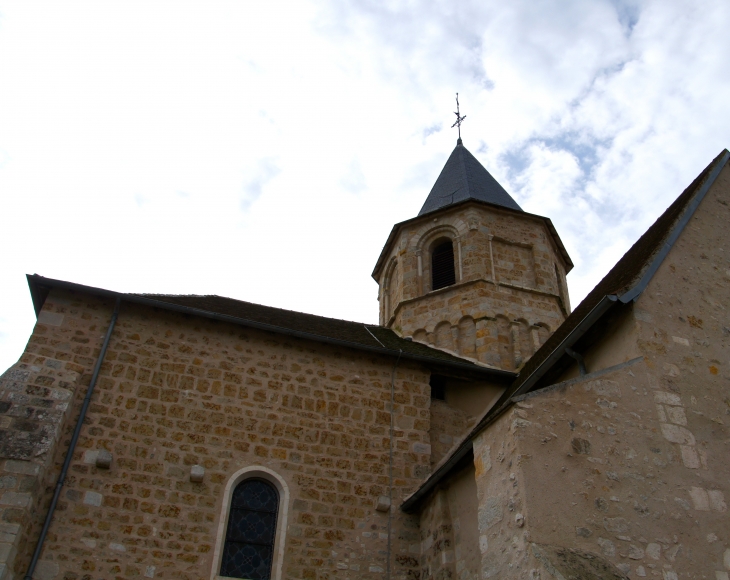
[0, 307, 109, 580]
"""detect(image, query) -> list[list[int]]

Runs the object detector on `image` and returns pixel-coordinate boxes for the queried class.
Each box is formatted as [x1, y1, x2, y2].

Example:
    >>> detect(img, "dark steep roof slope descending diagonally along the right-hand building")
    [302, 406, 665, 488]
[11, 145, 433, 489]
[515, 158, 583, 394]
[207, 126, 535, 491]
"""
[401, 149, 730, 513]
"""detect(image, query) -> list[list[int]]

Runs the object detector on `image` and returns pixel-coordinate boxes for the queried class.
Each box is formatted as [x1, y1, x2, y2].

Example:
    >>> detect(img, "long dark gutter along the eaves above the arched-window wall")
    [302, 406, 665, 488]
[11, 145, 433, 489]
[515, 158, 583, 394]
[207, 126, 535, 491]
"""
[27, 274, 515, 382]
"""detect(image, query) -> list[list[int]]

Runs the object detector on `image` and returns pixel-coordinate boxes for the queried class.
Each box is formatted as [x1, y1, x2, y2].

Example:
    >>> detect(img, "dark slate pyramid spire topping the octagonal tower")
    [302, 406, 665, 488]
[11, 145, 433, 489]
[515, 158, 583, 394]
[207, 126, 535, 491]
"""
[418, 139, 522, 215]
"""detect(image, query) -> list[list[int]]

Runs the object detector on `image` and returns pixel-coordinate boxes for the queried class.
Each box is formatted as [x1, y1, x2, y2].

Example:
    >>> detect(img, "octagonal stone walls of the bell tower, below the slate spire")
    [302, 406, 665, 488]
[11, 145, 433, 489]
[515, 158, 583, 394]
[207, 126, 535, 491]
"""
[379, 205, 569, 370]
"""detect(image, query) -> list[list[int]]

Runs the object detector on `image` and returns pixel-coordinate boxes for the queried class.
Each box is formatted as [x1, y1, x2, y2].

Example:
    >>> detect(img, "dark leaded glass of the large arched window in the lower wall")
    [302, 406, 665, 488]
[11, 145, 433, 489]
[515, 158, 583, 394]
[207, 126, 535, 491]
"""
[221, 479, 279, 580]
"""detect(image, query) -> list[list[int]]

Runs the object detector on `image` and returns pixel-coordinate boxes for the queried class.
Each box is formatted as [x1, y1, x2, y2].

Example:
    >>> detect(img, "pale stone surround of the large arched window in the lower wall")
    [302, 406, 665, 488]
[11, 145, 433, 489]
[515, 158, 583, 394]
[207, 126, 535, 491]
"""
[210, 465, 289, 580]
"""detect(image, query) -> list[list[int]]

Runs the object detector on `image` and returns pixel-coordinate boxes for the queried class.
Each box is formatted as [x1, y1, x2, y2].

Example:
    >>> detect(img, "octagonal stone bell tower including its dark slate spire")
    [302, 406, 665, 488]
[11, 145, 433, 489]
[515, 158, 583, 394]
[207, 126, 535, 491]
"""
[373, 139, 573, 370]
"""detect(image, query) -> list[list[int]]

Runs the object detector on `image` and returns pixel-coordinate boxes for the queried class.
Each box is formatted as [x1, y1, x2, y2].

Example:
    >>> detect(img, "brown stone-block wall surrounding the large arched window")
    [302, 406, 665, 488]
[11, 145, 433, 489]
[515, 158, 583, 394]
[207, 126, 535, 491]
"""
[6, 291, 430, 580]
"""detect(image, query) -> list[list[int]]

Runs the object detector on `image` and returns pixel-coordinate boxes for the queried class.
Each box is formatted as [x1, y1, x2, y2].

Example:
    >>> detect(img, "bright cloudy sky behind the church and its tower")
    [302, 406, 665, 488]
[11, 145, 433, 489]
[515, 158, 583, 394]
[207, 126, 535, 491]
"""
[0, 0, 730, 367]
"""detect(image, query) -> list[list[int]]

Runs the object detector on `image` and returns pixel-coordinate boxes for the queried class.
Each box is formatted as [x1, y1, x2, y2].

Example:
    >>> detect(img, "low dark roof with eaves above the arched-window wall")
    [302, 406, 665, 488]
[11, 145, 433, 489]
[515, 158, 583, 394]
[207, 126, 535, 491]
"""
[22, 274, 515, 382]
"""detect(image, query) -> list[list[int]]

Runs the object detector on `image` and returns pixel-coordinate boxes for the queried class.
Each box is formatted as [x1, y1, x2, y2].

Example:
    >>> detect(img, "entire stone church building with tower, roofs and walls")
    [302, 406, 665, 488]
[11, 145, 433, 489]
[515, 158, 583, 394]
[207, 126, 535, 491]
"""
[0, 139, 730, 580]
